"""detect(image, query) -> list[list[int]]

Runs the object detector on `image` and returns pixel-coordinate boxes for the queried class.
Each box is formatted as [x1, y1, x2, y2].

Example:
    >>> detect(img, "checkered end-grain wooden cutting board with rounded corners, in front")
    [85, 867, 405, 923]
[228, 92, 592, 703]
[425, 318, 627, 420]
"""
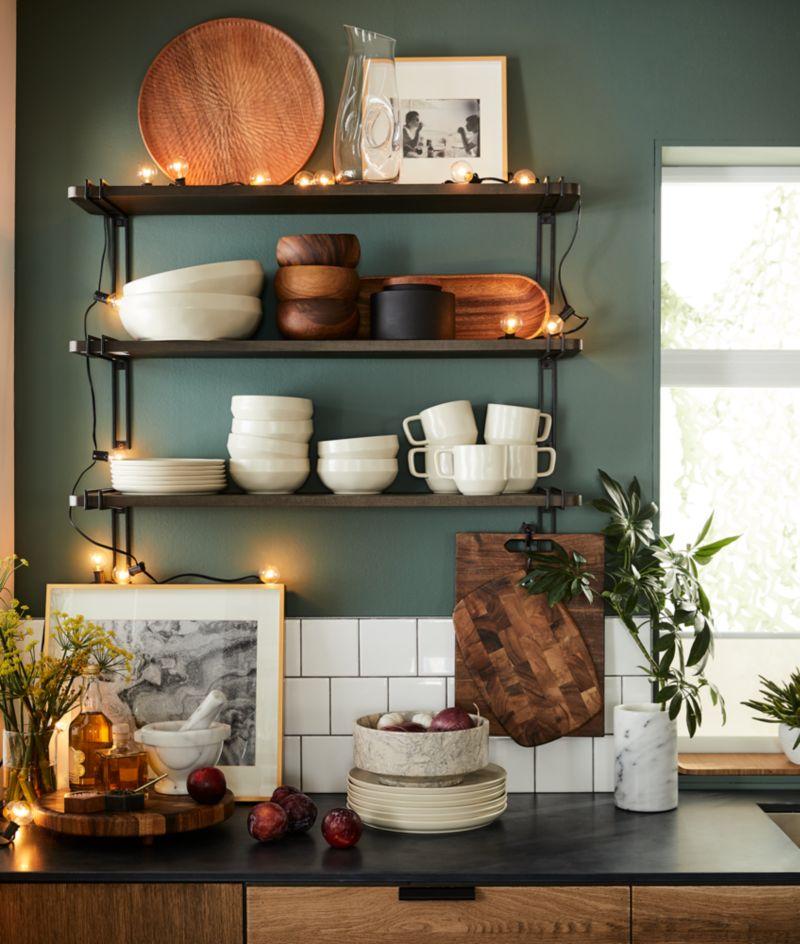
[453, 570, 603, 747]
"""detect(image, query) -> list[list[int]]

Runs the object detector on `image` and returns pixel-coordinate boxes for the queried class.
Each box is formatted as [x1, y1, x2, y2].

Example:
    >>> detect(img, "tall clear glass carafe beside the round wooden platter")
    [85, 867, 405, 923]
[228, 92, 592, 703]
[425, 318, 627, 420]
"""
[333, 26, 403, 183]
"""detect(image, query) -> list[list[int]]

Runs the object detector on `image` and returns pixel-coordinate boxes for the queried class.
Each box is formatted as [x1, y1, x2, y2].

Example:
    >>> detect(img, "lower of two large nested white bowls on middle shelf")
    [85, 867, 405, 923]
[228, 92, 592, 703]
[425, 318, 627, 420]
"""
[117, 292, 262, 341]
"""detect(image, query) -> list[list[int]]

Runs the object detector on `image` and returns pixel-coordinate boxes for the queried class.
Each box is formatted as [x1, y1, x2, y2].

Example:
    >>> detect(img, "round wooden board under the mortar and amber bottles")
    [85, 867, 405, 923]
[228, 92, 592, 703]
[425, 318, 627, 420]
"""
[33, 790, 236, 839]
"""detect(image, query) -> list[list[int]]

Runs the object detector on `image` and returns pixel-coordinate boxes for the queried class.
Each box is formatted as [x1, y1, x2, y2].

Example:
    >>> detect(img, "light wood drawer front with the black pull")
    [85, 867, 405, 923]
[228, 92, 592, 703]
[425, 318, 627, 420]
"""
[247, 886, 630, 944]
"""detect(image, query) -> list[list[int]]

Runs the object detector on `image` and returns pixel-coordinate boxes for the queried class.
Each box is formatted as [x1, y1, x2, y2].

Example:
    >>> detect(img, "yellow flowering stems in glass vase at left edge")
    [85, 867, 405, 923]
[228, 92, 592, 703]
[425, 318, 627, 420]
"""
[0, 555, 133, 806]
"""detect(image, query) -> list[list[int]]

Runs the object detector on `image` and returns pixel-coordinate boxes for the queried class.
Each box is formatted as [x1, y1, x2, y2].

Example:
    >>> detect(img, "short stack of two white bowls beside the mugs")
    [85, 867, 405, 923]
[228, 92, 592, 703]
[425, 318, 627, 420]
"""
[317, 435, 400, 495]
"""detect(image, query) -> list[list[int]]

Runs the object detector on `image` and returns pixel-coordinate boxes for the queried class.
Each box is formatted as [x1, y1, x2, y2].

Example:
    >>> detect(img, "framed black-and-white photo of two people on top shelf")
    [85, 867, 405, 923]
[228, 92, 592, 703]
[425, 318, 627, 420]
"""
[396, 56, 508, 184]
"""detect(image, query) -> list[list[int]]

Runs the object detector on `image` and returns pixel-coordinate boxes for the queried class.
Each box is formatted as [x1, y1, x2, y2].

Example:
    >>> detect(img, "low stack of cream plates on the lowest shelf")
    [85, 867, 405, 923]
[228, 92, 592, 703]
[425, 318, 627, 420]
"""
[110, 459, 226, 495]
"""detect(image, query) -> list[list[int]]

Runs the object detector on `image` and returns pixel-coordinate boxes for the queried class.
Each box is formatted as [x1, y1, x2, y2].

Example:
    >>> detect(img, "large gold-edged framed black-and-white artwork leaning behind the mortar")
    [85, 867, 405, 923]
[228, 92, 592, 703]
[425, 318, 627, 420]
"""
[45, 584, 284, 800]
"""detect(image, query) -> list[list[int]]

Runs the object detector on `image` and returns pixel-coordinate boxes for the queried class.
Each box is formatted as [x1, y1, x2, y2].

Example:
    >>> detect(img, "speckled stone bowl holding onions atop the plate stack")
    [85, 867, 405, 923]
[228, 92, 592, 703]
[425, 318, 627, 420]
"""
[353, 711, 489, 787]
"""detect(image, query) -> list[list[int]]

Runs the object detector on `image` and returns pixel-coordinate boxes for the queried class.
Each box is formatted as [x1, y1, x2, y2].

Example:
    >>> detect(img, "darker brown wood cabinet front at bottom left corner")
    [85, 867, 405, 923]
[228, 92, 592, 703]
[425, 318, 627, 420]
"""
[0, 882, 243, 944]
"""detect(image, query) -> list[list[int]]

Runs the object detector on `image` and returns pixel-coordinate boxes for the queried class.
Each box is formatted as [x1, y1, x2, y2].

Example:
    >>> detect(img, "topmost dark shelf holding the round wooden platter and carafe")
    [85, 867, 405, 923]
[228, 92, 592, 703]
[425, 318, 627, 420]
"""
[67, 183, 581, 218]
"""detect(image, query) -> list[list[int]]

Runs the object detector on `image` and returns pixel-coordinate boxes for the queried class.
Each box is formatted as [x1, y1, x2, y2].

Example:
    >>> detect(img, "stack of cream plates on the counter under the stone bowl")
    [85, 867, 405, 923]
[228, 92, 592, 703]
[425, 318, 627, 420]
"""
[347, 764, 508, 833]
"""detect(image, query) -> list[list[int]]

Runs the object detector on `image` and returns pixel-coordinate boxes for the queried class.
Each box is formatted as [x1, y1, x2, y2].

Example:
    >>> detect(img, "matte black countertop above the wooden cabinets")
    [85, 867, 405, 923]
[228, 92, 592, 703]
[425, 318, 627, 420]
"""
[0, 792, 800, 885]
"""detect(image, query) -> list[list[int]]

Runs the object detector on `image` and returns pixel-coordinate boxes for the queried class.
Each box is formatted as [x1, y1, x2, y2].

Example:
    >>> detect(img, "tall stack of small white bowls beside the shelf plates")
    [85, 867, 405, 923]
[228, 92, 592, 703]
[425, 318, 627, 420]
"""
[228, 396, 314, 495]
